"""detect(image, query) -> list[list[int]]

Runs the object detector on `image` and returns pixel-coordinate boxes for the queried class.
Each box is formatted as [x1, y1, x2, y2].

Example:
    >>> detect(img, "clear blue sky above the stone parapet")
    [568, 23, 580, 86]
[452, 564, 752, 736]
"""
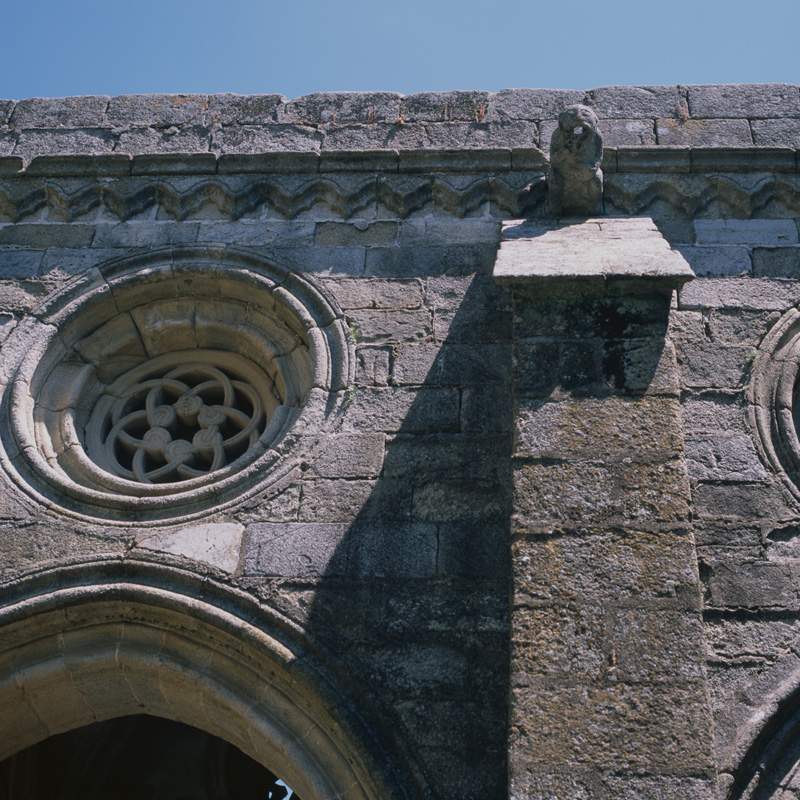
[0, 0, 800, 99]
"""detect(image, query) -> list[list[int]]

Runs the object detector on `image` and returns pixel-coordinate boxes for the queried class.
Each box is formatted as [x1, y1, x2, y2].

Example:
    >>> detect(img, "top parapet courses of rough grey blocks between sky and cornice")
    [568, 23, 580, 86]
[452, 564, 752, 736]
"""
[0, 84, 800, 161]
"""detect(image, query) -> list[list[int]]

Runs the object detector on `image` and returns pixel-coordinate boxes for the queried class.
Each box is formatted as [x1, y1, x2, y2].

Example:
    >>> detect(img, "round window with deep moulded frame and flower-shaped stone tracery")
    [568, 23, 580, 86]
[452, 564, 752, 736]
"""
[0, 246, 353, 524]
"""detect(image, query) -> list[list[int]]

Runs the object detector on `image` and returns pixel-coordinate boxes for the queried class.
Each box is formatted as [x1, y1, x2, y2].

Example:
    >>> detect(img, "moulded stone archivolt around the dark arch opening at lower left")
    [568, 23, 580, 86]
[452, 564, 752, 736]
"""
[0, 564, 427, 800]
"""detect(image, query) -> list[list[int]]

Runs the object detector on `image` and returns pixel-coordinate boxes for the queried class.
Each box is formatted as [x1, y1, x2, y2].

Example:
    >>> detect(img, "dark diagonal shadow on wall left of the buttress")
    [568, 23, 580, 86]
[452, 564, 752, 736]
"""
[304, 276, 511, 800]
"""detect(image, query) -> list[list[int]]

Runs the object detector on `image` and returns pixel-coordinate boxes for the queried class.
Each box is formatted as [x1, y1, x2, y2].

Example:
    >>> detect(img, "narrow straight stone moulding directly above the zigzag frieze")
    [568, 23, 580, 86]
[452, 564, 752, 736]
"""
[0, 147, 800, 178]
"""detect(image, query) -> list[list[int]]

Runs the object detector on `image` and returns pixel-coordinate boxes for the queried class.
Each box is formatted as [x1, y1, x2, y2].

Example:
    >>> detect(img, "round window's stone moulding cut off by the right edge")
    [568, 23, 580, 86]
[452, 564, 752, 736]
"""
[747, 308, 800, 500]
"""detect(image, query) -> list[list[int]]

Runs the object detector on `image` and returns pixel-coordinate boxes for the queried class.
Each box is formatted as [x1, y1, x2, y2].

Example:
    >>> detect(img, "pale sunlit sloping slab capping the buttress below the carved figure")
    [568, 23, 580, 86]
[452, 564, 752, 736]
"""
[493, 217, 695, 291]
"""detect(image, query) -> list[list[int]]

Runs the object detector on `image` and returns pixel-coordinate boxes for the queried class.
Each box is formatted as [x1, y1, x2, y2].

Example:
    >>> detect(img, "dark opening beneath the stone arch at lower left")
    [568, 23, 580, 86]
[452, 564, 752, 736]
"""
[0, 714, 300, 800]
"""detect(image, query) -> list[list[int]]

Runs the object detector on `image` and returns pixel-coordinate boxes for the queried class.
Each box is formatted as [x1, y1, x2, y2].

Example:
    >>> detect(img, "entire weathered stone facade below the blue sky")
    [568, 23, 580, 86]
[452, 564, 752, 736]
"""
[0, 84, 800, 800]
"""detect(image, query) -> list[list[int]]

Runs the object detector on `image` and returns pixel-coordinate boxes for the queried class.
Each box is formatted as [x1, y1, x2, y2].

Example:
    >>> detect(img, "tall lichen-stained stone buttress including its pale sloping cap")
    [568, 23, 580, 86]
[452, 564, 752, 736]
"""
[495, 219, 715, 798]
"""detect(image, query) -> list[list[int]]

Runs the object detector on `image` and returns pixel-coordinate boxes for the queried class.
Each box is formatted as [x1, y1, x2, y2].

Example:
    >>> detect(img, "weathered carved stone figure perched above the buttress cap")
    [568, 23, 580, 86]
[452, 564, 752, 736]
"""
[547, 105, 603, 216]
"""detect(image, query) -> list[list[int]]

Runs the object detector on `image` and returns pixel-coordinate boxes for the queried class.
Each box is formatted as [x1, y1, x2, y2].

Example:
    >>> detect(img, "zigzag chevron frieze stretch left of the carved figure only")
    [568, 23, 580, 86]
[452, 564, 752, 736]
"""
[0, 173, 545, 222]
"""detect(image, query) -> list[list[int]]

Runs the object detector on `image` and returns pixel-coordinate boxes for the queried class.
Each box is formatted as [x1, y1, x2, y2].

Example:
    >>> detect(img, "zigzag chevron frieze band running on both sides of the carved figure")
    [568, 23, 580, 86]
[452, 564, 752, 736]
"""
[0, 173, 800, 222]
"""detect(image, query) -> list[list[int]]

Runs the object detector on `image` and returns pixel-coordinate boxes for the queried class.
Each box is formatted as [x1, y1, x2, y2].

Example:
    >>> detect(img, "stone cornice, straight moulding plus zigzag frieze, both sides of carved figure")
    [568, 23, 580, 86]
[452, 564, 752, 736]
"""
[0, 147, 800, 222]
